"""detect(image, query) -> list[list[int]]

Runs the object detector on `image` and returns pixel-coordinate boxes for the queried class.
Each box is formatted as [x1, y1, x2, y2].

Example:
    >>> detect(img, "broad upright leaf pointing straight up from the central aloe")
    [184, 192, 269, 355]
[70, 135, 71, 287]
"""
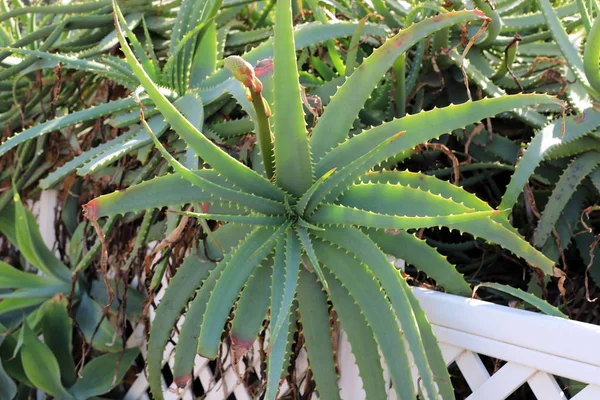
[273, 0, 312, 196]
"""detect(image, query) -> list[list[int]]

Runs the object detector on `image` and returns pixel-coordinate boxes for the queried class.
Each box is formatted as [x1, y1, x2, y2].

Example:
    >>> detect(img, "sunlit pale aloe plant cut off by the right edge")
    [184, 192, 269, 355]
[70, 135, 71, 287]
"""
[488, 0, 600, 283]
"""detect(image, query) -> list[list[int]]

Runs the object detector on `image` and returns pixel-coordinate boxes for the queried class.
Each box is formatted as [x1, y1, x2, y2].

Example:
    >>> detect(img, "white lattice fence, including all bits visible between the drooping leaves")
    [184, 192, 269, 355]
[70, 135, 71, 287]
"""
[34, 192, 600, 400]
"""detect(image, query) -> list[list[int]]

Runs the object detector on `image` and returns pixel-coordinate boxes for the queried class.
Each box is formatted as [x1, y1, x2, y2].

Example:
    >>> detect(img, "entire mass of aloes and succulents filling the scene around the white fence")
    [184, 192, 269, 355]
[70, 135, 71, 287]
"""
[0, 0, 600, 399]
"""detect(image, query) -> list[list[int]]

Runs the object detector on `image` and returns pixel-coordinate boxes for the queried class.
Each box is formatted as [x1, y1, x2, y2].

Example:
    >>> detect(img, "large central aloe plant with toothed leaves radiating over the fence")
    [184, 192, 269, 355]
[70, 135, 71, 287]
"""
[75, 1, 559, 399]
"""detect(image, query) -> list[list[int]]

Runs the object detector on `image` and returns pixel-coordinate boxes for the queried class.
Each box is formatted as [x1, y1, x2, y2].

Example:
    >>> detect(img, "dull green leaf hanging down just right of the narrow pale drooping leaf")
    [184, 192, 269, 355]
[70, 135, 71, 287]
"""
[298, 268, 340, 400]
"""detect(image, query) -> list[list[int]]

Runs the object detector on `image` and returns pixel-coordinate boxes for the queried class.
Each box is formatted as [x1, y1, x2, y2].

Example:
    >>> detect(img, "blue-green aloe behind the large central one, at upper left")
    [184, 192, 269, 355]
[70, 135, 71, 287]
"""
[0, 0, 385, 188]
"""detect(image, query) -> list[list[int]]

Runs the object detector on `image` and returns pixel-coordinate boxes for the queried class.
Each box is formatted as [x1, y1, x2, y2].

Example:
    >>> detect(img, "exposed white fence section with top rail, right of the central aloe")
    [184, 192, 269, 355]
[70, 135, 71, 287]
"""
[414, 289, 600, 400]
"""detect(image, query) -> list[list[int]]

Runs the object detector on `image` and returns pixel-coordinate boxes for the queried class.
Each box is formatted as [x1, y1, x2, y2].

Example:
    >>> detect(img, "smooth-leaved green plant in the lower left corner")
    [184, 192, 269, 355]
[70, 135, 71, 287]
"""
[0, 195, 142, 399]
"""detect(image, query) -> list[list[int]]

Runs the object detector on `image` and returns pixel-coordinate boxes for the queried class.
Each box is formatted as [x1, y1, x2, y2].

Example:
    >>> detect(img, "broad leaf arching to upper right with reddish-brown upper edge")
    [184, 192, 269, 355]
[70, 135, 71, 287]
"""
[310, 11, 483, 161]
